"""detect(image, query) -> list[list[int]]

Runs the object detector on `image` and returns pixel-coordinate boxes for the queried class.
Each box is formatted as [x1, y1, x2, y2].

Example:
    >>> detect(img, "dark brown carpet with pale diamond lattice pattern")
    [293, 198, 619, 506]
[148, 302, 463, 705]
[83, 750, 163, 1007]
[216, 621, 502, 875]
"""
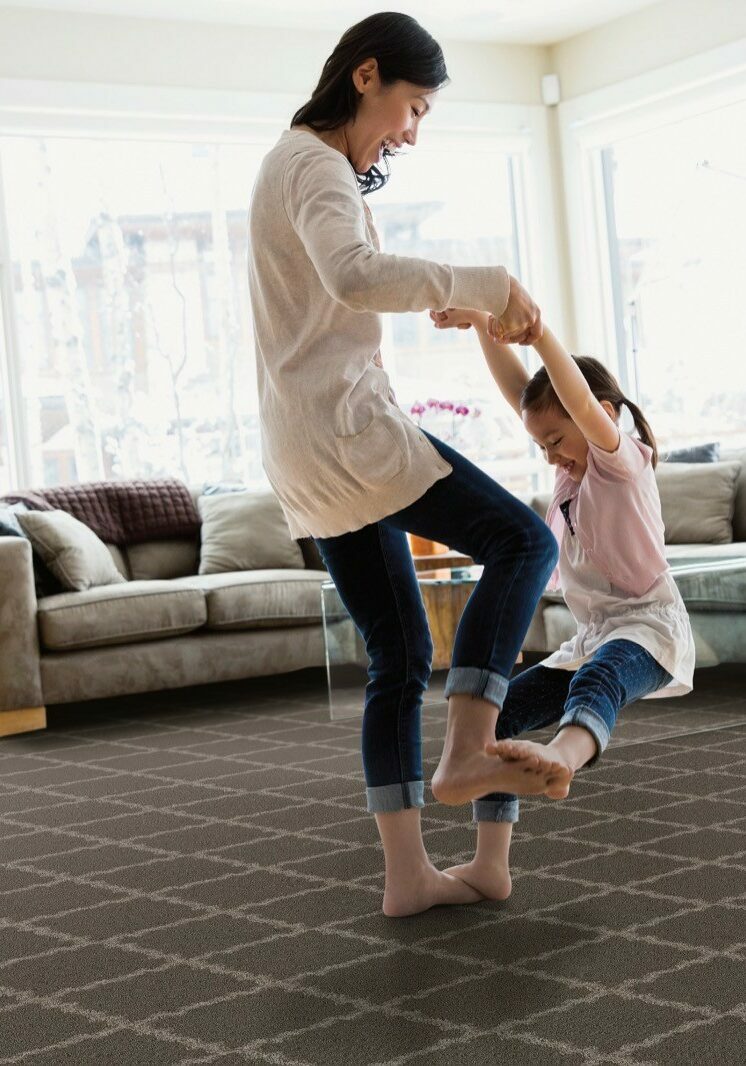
[0, 667, 746, 1066]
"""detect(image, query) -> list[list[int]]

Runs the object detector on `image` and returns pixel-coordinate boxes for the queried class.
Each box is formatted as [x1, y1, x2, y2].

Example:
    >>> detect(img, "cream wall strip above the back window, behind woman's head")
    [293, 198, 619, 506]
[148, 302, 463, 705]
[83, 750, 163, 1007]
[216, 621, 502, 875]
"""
[0, 7, 549, 103]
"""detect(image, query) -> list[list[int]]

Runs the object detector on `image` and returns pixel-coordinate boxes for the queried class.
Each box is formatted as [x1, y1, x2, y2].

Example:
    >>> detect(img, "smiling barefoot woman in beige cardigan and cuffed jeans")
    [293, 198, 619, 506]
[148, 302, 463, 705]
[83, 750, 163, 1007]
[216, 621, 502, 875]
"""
[249, 13, 556, 916]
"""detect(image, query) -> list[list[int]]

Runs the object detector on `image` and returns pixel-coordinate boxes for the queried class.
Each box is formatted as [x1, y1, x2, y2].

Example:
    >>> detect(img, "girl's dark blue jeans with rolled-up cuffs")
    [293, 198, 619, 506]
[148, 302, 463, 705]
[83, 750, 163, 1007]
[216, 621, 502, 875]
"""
[472, 641, 671, 822]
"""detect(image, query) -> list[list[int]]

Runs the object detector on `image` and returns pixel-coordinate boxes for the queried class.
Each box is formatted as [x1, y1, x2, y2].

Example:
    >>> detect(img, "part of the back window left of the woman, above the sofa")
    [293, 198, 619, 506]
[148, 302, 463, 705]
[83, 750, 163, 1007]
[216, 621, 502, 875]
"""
[0, 136, 266, 494]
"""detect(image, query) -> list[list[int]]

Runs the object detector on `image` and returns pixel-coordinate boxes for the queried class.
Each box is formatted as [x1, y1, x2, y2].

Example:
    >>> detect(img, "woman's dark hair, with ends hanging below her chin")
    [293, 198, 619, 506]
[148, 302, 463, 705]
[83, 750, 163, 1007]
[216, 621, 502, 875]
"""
[290, 12, 449, 196]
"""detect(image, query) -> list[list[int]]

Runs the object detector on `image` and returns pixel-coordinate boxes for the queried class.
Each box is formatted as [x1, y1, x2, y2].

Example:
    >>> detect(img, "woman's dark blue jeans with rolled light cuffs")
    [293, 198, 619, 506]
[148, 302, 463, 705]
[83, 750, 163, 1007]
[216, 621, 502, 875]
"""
[314, 434, 557, 812]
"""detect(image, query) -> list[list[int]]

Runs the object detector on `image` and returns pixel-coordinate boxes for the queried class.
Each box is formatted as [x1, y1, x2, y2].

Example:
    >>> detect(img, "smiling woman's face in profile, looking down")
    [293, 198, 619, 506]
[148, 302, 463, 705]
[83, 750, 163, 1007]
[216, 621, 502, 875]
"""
[344, 60, 437, 174]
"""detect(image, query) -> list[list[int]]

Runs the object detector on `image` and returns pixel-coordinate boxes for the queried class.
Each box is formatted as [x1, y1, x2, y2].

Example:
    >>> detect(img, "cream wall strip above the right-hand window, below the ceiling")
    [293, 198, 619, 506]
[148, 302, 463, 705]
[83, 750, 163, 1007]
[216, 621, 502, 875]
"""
[549, 0, 746, 99]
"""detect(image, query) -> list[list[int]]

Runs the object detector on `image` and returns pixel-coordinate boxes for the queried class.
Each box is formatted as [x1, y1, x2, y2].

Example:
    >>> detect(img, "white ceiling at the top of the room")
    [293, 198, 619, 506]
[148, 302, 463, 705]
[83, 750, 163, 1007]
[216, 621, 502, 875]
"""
[0, 0, 658, 45]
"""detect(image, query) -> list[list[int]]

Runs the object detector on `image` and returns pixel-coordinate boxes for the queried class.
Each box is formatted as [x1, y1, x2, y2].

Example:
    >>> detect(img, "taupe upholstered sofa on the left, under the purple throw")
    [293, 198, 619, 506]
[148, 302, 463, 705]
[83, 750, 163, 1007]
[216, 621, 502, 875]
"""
[0, 486, 328, 736]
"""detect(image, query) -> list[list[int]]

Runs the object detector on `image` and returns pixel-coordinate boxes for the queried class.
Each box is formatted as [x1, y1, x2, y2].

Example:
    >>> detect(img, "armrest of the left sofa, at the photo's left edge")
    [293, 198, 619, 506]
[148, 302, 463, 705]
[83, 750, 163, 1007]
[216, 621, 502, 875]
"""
[0, 536, 44, 711]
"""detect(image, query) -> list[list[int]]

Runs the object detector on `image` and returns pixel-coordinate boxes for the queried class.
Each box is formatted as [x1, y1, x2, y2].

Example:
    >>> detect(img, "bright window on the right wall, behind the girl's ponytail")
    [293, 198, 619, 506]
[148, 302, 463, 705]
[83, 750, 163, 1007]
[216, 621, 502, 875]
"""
[575, 74, 746, 450]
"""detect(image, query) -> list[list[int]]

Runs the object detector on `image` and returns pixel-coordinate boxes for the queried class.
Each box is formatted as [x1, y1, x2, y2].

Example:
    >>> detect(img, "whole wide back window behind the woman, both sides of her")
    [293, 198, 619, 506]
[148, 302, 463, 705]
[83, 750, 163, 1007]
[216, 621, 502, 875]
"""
[0, 102, 540, 491]
